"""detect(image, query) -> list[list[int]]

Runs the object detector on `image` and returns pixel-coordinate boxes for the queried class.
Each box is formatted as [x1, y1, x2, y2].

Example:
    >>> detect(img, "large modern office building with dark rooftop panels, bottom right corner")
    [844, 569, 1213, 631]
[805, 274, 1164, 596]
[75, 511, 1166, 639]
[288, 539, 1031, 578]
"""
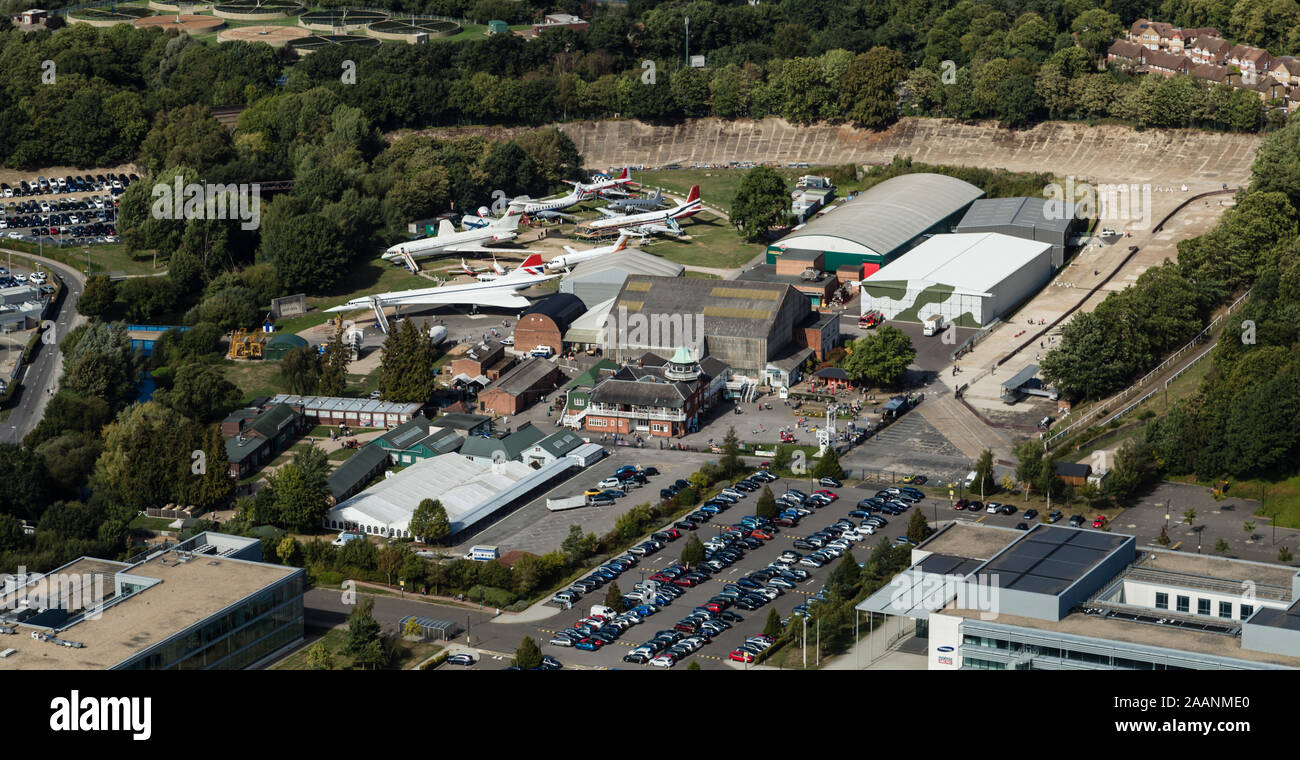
[858, 521, 1300, 670]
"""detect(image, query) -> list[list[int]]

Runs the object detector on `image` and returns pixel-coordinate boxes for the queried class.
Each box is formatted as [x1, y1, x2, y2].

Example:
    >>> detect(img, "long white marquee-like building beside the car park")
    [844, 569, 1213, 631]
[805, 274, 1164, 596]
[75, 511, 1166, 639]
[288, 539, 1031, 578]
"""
[322, 453, 582, 538]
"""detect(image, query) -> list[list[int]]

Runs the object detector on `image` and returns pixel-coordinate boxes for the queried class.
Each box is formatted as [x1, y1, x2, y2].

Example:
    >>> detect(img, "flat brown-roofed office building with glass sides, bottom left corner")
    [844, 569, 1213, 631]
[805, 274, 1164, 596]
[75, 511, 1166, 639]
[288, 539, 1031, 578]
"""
[0, 533, 306, 672]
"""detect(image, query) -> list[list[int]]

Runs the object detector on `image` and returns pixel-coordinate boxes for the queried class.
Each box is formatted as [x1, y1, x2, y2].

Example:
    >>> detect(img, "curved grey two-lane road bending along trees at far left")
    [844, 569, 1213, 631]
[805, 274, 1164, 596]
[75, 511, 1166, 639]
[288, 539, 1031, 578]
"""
[0, 248, 86, 443]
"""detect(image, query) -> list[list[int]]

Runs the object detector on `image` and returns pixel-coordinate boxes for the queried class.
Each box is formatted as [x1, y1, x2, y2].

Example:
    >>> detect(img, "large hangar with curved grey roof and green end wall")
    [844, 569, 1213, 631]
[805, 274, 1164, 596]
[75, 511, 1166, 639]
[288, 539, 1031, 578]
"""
[767, 173, 984, 275]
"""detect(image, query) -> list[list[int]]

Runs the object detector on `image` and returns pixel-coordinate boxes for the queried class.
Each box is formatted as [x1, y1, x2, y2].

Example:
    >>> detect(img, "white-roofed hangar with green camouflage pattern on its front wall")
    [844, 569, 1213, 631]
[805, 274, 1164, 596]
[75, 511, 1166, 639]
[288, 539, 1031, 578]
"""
[862, 233, 1056, 327]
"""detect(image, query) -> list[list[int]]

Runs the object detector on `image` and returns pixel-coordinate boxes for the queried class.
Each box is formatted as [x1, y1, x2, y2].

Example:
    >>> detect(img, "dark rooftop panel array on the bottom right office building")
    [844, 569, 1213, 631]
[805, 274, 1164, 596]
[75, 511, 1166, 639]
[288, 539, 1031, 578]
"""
[980, 526, 1126, 596]
